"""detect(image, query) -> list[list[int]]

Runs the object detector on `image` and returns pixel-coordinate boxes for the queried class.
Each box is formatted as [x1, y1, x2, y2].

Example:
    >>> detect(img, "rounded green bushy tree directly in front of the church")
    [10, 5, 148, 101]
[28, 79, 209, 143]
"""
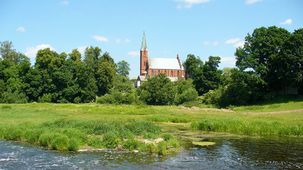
[139, 74, 175, 105]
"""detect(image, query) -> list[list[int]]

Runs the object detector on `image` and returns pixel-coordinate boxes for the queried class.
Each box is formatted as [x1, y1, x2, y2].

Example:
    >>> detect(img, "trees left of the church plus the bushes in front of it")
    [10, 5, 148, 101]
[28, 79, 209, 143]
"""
[0, 41, 198, 105]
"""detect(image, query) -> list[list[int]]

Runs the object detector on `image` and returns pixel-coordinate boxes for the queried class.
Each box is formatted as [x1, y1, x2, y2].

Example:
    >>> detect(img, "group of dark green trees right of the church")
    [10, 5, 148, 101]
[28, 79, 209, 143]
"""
[184, 26, 303, 107]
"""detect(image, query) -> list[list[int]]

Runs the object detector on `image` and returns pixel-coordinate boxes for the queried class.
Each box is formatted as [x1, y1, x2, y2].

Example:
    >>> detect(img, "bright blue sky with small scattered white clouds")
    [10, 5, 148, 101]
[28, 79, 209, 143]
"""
[0, 0, 303, 78]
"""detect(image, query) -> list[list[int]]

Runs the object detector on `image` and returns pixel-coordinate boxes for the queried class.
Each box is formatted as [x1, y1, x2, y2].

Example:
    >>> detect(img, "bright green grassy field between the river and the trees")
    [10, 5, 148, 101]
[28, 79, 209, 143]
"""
[0, 101, 303, 154]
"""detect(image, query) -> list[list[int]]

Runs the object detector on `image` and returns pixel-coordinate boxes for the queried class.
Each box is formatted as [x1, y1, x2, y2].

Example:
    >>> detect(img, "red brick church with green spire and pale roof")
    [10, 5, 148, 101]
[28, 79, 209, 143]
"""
[136, 33, 185, 87]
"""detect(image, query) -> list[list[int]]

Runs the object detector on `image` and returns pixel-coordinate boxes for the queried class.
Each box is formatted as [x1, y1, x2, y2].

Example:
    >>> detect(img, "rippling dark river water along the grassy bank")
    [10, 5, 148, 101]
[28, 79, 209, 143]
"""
[0, 138, 303, 169]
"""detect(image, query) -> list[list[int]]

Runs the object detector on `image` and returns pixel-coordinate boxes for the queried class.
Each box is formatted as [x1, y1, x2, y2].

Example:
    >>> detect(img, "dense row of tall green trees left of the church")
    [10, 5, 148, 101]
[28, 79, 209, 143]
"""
[0, 42, 120, 103]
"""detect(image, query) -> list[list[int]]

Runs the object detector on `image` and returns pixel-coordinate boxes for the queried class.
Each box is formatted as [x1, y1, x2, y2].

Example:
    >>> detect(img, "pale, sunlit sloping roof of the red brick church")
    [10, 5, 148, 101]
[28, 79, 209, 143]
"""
[148, 58, 183, 70]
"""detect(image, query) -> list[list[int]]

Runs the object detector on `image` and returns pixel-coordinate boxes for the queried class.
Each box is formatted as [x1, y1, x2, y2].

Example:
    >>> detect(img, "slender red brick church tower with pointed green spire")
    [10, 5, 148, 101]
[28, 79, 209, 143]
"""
[140, 32, 148, 76]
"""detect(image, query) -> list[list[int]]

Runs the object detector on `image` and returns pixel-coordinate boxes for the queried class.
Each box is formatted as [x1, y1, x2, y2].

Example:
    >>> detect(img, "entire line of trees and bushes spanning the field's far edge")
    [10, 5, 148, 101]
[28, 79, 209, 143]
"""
[0, 26, 303, 107]
